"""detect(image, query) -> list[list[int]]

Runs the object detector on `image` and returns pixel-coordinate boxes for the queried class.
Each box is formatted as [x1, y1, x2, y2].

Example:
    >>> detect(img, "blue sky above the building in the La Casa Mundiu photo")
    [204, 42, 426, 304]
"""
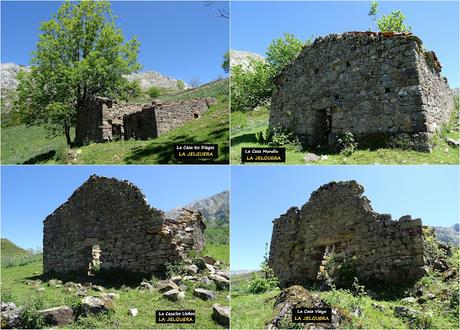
[231, 1, 459, 88]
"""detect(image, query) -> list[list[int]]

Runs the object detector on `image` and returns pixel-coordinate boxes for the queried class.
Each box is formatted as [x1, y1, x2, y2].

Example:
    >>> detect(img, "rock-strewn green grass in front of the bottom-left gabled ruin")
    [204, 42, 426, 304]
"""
[0, 244, 229, 329]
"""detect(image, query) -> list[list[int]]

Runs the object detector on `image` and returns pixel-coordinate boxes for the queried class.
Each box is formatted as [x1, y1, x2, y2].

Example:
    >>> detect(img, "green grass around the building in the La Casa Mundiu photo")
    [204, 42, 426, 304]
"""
[230, 98, 460, 165]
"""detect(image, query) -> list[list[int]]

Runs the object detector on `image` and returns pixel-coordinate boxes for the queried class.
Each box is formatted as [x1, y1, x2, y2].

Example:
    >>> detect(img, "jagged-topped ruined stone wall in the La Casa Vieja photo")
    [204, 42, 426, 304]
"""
[269, 181, 425, 287]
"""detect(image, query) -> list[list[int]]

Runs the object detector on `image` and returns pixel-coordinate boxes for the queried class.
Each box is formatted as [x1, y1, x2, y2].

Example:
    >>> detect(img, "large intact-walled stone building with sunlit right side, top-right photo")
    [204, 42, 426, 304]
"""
[269, 32, 454, 151]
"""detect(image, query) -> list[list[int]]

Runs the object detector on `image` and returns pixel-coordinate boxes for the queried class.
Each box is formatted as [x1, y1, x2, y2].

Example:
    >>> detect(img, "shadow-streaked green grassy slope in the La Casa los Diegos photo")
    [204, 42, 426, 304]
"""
[1, 80, 229, 164]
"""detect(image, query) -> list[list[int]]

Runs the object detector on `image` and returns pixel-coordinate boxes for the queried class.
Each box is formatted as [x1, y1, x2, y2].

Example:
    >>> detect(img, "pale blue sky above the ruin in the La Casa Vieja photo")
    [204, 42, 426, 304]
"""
[231, 165, 459, 270]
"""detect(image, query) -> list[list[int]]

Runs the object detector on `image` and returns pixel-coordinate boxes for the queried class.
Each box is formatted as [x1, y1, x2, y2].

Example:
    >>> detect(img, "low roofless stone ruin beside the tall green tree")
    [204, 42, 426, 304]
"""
[75, 97, 216, 143]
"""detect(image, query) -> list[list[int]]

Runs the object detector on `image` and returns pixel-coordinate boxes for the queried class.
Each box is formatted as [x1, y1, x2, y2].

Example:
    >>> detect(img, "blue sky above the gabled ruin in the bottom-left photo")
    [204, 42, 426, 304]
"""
[1, 165, 230, 248]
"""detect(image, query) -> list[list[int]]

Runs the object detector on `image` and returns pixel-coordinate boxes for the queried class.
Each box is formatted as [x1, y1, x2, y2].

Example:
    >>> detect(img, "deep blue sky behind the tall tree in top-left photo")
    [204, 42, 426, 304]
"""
[1, 1, 229, 83]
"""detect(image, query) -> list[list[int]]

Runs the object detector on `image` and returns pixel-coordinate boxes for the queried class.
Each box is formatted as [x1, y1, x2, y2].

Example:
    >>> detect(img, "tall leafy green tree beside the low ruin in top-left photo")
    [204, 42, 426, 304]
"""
[16, 1, 140, 145]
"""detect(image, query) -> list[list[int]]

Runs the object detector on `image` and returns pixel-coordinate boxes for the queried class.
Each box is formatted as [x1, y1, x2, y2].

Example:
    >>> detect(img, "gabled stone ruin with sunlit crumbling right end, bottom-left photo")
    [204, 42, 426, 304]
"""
[43, 175, 206, 274]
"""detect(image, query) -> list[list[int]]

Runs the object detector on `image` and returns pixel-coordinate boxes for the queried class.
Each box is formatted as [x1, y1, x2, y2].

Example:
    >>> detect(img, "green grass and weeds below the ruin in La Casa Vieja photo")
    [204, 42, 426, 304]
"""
[231, 250, 460, 329]
